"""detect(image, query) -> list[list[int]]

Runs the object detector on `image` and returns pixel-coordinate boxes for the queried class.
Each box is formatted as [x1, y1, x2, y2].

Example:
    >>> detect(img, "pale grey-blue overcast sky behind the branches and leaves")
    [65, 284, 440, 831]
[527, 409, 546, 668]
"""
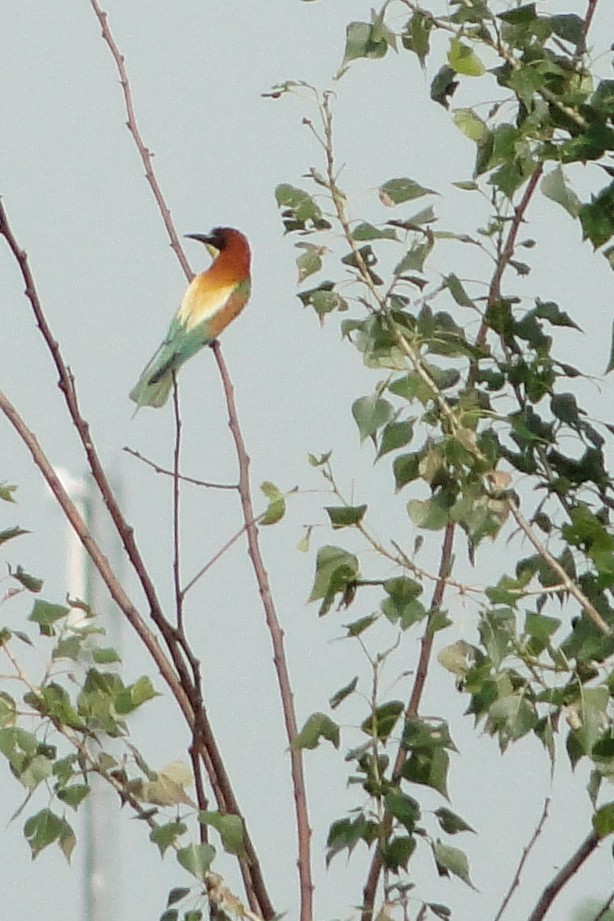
[0, 0, 614, 921]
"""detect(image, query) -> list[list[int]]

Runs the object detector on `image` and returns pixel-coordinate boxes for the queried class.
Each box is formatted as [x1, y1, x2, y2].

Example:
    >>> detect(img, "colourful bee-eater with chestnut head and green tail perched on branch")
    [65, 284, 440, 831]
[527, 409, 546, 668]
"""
[130, 227, 251, 411]
